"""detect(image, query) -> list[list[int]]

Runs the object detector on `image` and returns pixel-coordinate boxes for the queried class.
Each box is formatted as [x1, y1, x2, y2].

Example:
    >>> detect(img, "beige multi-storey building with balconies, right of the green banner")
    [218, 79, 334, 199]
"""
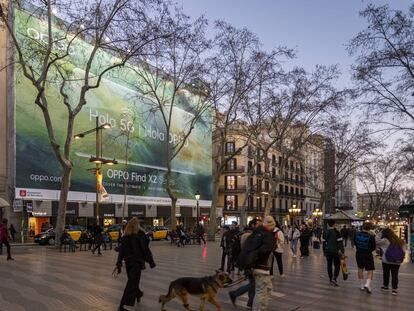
[213, 124, 305, 225]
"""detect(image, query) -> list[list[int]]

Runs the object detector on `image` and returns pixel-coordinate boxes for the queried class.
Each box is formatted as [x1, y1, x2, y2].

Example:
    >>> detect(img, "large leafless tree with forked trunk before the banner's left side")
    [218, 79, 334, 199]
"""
[0, 0, 165, 243]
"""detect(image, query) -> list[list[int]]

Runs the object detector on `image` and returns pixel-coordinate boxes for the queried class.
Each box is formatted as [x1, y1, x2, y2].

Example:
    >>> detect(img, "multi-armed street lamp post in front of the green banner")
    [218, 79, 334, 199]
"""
[74, 117, 118, 225]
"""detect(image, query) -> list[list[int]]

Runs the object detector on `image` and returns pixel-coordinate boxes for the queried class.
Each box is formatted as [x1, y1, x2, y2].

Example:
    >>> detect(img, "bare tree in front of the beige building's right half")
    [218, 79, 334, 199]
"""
[247, 66, 344, 215]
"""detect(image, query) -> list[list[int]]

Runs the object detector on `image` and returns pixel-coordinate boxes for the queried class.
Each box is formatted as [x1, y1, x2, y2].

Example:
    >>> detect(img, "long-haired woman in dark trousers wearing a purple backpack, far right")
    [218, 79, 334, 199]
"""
[376, 228, 405, 296]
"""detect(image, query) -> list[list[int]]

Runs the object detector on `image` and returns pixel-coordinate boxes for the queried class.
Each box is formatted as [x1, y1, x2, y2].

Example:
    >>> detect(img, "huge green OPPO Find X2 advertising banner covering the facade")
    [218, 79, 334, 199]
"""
[15, 10, 212, 206]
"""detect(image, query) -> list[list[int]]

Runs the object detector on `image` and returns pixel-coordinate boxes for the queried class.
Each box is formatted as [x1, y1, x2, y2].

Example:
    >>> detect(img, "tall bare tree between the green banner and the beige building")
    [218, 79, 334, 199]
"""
[207, 21, 292, 240]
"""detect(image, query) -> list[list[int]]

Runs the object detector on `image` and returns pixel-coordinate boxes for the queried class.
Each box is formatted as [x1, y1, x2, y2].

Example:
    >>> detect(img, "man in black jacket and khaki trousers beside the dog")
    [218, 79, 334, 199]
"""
[240, 216, 276, 311]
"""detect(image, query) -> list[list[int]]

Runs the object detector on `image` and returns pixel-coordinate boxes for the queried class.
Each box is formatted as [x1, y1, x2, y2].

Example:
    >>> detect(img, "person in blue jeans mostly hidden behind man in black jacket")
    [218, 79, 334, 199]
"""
[229, 218, 262, 308]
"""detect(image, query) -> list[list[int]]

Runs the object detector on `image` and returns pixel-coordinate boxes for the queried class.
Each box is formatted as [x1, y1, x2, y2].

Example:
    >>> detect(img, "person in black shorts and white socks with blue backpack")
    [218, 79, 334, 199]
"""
[355, 222, 376, 294]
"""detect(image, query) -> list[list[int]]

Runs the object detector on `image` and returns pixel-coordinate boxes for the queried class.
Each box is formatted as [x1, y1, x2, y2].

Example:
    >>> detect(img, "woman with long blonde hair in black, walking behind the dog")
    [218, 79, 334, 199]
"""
[116, 217, 155, 311]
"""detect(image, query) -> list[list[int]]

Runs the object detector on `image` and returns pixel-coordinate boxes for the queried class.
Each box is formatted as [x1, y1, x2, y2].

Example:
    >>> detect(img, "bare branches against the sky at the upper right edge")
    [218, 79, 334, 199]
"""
[348, 4, 414, 134]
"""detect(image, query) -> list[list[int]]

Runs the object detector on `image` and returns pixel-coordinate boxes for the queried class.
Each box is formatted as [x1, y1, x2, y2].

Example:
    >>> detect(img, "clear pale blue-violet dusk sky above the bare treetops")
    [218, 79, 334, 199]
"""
[177, 0, 413, 86]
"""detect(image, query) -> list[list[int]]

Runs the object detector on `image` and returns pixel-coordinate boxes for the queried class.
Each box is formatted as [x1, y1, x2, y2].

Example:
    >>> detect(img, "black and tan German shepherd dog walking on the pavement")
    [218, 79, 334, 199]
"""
[159, 271, 233, 311]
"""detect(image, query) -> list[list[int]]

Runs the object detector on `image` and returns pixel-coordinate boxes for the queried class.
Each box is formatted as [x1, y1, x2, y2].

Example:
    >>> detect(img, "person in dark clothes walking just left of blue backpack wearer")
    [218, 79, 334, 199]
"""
[323, 219, 345, 286]
